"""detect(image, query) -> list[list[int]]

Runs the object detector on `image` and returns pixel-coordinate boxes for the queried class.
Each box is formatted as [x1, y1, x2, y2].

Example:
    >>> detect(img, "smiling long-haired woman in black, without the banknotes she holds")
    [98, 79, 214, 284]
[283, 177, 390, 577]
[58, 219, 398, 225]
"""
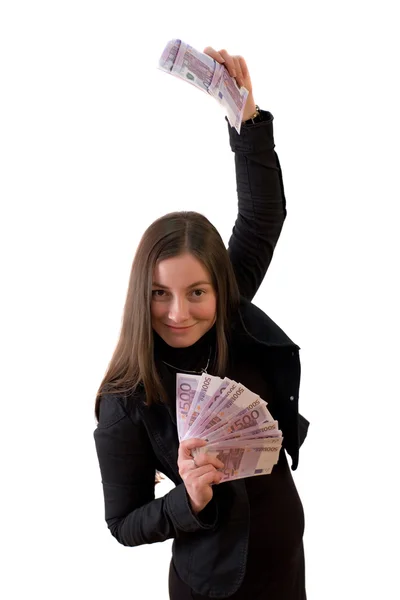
[94, 48, 308, 600]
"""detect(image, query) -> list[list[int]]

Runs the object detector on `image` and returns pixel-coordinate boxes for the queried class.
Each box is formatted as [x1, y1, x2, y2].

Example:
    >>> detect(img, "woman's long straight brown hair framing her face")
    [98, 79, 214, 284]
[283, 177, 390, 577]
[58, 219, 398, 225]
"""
[95, 211, 240, 419]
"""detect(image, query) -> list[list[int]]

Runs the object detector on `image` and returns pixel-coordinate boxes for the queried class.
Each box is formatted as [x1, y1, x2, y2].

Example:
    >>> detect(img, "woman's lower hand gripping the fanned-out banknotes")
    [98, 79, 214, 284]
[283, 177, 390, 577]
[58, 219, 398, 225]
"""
[178, 438, 224, 514]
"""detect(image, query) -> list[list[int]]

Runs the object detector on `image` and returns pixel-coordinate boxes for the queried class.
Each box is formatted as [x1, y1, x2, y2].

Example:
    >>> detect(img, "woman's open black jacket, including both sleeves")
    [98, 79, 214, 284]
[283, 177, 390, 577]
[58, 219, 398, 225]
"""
[94, 113, 308, 598]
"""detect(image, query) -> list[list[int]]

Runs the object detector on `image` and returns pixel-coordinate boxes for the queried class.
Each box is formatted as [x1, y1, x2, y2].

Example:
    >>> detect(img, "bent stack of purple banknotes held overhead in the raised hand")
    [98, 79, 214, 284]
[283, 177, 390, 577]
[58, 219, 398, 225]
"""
[158, 40, 249, 134]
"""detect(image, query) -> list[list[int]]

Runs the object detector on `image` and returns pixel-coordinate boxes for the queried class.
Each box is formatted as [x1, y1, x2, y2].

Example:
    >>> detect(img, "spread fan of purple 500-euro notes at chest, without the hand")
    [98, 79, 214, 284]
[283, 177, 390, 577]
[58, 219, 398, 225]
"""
[176, 373, 283, 481]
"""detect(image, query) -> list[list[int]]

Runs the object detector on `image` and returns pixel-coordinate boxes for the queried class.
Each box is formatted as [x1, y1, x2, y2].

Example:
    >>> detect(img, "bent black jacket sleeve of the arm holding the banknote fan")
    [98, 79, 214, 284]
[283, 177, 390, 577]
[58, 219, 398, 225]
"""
[94, 394, 216, 546]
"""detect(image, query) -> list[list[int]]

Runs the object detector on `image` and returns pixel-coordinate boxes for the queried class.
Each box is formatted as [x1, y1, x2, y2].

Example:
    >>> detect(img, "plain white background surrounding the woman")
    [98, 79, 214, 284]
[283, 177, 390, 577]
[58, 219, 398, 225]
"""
[0, 0, 400, 600]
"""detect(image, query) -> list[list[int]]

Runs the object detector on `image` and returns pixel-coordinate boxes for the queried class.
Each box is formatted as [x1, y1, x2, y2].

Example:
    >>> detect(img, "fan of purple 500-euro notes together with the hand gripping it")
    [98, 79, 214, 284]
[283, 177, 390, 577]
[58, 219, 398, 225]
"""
[176, 372, 283, 482]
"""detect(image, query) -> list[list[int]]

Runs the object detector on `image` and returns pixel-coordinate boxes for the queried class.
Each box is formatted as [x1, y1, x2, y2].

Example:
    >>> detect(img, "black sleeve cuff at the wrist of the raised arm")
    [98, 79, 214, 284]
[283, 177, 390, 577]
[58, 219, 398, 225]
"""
[225, 110, 275, 154]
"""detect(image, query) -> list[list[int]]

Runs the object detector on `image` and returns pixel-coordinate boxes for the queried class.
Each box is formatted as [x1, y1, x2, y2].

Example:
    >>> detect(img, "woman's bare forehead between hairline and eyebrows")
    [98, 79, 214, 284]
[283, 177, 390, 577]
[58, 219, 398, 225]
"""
[153, 254, 211, 287]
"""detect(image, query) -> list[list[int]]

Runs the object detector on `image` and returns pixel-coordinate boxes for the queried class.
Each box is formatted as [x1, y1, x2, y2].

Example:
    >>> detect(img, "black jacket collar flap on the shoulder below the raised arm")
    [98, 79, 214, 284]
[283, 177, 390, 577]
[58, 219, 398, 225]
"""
[233, 298, 300, 350]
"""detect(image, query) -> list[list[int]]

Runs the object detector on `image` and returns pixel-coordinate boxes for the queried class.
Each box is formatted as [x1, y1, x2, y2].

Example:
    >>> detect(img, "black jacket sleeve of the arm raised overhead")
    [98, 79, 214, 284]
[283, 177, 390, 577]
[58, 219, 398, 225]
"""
[226, 111, 286, 300]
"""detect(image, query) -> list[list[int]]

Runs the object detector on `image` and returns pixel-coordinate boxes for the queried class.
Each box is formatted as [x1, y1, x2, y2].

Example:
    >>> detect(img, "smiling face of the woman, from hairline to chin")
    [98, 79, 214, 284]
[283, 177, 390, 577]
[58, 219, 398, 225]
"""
[151, 253, 217, 348]
